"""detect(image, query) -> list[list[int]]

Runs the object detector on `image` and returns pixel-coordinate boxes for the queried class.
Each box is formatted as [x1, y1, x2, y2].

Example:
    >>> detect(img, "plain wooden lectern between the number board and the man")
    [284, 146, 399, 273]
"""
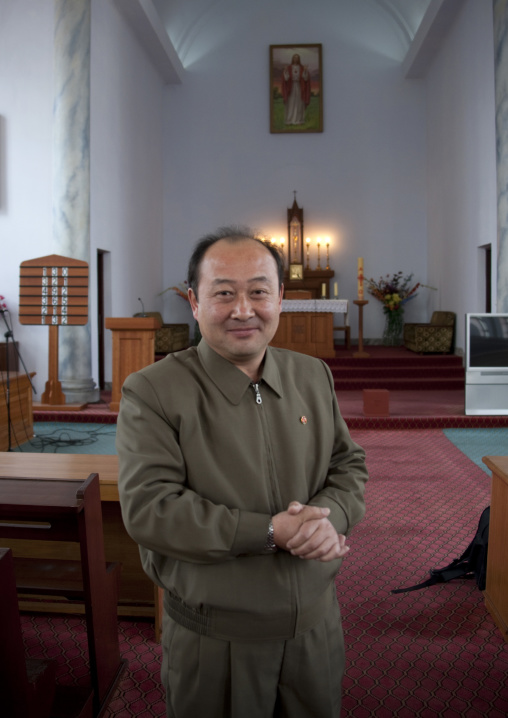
[105, 317, 161, 411]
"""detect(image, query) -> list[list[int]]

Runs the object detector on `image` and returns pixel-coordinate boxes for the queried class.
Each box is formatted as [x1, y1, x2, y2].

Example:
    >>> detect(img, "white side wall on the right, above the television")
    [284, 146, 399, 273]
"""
[426, 0, 497, 349]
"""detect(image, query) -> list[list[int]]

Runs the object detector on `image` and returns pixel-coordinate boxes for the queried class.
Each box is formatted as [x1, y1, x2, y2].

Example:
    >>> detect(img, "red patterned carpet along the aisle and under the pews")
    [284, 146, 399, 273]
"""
[18, 430, 508, 718]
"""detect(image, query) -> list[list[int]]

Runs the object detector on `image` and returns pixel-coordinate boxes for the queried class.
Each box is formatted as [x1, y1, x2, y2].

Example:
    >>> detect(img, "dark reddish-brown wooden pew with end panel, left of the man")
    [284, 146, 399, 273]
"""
[0, 474, 125, 717]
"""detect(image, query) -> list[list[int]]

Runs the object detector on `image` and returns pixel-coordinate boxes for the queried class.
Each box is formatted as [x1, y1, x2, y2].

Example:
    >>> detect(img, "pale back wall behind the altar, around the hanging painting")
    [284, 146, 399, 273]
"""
[159, 0, 427, 338]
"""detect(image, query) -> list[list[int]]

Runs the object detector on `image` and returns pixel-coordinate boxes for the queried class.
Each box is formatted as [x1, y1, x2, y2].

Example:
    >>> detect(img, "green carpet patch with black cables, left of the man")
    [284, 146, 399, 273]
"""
[13, 421, 116, 454]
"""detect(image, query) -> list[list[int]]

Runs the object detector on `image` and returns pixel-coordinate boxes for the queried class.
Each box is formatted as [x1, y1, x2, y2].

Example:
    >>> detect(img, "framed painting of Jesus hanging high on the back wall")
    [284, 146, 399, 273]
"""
[270, 45, 323, 133]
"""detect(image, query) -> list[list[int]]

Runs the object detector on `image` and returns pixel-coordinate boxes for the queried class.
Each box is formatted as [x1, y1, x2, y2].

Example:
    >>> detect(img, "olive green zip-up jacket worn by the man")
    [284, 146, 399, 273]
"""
[117, 340, 367, 639]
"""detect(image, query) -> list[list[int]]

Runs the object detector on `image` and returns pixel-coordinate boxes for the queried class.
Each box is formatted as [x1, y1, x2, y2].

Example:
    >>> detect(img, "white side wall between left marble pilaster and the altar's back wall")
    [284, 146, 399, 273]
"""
[90, 0, 163, 381]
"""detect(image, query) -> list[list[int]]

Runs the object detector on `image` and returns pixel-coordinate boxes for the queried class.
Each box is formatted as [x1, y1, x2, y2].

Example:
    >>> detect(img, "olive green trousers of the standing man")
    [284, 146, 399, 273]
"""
[161, 605, 344, 718]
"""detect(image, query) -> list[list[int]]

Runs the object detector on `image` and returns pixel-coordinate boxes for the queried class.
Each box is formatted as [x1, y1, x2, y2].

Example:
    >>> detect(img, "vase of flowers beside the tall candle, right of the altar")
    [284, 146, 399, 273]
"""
[367, 272, 420, 346]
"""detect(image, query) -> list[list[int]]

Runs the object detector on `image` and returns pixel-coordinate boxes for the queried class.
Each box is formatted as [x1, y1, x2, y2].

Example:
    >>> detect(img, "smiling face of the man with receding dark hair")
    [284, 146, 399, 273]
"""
[189, 239, 282, 375]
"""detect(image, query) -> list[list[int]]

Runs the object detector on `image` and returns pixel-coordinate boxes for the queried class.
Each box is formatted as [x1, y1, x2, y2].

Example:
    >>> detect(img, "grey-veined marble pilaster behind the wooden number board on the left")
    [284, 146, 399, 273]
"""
[53, 0, 99, 403]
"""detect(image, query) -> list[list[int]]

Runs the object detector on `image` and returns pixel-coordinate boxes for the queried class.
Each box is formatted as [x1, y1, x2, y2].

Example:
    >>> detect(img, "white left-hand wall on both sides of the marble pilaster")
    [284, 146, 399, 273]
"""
[0, 0, 163, 390]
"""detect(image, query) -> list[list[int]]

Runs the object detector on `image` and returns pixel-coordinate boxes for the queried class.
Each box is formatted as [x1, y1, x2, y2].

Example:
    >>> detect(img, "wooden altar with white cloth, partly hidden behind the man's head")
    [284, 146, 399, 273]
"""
[270, 299, 348, 358]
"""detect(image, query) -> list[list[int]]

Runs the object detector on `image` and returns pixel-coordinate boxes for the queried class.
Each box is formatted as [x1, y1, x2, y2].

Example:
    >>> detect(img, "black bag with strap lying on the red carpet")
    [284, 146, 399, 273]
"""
[392, 506, 490, 593]
